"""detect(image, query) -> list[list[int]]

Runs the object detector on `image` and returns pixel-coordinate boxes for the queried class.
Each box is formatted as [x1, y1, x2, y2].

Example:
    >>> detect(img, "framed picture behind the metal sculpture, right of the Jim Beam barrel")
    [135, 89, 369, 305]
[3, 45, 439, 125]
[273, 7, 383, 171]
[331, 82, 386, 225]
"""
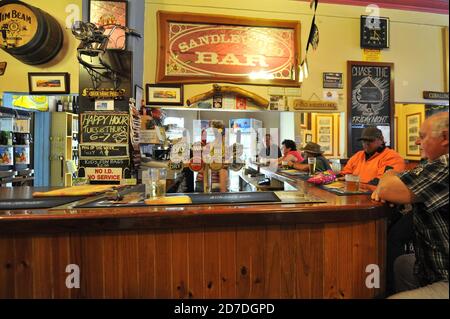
[89, 0, 128, 50]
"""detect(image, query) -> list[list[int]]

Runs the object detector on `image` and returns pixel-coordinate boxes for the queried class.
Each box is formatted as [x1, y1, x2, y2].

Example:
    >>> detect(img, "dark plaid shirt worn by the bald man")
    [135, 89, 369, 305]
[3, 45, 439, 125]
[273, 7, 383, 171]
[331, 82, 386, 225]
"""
[399, 154, 449, 286]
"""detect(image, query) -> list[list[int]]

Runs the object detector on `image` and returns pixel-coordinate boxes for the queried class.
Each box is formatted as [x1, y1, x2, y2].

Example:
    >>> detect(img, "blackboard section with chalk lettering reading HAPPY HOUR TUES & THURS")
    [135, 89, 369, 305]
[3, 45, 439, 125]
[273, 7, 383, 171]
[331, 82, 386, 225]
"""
[81, 113, 130, 144]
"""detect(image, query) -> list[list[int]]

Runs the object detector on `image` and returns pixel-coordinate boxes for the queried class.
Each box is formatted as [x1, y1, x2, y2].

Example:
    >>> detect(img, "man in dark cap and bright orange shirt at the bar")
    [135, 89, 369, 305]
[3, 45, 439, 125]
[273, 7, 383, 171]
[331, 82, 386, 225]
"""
[340, 127, 405, 185]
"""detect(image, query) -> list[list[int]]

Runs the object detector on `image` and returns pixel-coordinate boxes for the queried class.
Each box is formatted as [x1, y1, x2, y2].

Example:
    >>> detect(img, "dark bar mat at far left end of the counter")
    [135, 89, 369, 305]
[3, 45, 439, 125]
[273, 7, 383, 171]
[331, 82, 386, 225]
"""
[0, 196, 85, 210]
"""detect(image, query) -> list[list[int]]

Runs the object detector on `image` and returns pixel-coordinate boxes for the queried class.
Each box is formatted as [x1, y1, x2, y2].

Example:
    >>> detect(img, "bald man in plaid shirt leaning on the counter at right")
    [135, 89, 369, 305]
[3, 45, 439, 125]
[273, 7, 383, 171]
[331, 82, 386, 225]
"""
[372, 112, 449, 299]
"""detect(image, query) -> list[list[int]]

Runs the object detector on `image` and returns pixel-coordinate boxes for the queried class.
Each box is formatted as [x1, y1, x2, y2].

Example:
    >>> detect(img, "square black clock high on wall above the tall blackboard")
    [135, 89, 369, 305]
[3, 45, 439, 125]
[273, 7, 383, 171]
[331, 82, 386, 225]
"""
[361, 16, 389, 49]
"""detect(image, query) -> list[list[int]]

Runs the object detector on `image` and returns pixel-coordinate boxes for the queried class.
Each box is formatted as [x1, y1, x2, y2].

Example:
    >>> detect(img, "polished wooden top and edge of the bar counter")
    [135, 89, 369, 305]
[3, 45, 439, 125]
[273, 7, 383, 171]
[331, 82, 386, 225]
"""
[0, 179, 389, 233]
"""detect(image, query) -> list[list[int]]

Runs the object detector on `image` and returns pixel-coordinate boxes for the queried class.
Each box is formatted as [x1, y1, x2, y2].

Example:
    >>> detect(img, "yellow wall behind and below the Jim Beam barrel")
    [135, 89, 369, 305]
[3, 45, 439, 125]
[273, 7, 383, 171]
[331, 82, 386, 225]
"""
[0, 0, 82, 94]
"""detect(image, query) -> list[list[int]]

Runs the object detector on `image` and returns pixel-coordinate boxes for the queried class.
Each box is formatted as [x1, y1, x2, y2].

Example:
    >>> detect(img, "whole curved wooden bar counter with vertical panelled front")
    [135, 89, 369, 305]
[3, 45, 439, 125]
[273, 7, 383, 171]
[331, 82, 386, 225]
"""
[0, 181, 390, 298]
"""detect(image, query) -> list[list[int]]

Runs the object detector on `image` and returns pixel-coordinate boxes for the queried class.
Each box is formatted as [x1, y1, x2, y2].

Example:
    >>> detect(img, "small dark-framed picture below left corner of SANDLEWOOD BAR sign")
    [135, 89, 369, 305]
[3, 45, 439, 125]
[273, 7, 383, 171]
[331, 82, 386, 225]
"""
[145, 84, 184, 106]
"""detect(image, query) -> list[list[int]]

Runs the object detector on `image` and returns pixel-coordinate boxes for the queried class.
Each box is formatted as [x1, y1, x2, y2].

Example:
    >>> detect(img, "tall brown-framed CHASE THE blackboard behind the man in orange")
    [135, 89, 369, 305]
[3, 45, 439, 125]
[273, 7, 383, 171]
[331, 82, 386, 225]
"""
[347, 61, 394, 157]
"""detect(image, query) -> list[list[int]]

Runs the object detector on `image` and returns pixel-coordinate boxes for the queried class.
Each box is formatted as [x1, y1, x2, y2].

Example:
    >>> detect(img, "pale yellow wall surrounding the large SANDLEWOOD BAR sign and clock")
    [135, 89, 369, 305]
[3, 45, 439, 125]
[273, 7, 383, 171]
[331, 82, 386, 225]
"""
[143, 0, 448, 112]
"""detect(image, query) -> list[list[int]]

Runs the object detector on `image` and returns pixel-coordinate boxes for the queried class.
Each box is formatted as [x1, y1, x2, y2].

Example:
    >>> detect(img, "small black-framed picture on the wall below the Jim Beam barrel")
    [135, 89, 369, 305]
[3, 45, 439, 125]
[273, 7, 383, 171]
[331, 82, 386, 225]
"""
[28, 72, 70, 94]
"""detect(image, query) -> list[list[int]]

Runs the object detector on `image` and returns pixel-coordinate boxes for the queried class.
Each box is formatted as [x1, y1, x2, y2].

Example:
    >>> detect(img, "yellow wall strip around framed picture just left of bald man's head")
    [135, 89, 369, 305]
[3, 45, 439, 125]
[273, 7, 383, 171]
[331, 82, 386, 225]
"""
[395, 104, 425, 161]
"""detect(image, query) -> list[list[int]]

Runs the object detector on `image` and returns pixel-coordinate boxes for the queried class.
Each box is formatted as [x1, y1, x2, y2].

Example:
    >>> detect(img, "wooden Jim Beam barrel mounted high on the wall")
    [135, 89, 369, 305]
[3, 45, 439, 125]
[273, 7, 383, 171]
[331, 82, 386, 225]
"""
[0, 1, 63, 65]
